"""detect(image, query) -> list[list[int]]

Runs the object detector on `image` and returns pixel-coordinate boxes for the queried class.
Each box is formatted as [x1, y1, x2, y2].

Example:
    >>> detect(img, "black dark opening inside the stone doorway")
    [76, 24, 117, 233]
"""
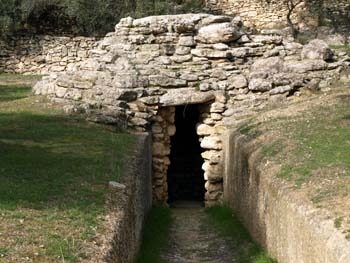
[168, 105, 205, 203]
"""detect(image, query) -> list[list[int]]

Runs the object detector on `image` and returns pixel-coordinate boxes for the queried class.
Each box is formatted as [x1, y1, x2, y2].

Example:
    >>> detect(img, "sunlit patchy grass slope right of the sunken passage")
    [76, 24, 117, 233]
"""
[241, 83, 350, 239]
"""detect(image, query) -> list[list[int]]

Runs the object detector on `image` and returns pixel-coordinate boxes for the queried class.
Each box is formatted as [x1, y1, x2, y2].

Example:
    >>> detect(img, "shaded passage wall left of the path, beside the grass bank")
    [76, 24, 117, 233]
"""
[104, 134, 152, 263]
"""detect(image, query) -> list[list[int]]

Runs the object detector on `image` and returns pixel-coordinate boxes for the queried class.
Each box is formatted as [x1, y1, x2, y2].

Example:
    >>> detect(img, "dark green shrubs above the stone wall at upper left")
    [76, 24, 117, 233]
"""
[0, 0, 203, 37]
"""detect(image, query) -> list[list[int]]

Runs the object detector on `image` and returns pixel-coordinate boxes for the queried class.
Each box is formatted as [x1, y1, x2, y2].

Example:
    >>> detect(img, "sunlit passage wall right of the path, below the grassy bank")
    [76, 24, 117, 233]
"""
[224, 130, 350, 263]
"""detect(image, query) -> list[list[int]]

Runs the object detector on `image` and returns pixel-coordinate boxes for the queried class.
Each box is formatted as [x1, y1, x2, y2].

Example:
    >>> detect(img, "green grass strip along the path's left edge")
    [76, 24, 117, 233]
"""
[137, 206, 172, 263]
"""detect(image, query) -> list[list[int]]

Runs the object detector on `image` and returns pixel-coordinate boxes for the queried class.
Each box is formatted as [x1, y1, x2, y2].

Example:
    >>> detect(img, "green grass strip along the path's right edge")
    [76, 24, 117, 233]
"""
[206, 206, 275, 263]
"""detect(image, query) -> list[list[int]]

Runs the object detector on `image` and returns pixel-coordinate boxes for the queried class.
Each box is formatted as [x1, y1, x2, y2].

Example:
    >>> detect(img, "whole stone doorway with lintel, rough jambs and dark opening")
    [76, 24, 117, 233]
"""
[152, 92, 223, 205]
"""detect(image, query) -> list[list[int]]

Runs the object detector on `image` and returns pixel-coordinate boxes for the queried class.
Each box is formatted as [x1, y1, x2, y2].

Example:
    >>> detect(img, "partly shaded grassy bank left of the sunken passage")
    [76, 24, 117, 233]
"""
[0, 76, 134, 262]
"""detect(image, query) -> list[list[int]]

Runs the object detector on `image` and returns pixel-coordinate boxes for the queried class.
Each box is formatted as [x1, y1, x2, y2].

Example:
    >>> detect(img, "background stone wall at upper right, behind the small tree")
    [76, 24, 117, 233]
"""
[206, 0, 350, 41]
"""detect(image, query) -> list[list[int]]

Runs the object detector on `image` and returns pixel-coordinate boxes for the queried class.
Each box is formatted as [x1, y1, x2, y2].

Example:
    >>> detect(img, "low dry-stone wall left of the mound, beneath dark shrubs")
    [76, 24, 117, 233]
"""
[0, 35, 97, 74]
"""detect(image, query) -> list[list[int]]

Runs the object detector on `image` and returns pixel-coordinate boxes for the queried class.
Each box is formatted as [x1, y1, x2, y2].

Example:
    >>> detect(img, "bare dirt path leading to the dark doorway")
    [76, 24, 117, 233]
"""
[162, 205, 235, 263]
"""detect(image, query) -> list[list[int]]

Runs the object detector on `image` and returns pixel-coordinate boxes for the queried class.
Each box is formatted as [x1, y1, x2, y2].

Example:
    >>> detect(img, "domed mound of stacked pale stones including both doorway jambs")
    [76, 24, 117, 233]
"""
[34, 14, 348, 205]
